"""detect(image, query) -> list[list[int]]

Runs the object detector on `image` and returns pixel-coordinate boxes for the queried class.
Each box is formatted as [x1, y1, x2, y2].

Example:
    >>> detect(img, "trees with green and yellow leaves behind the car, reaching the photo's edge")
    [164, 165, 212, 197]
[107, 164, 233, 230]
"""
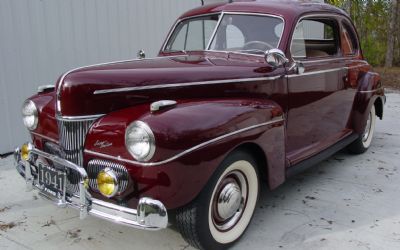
[326, 0, 400, 66]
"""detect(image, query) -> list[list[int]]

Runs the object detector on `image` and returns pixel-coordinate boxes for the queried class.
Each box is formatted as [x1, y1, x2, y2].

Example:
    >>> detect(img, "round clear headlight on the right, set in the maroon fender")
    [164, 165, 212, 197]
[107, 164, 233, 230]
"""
[125, 121, 156, 161]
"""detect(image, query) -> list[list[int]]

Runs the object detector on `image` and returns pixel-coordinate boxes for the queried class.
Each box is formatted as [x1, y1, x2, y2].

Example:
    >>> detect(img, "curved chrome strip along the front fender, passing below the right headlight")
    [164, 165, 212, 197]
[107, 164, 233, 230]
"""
[85, 116, 284, 167]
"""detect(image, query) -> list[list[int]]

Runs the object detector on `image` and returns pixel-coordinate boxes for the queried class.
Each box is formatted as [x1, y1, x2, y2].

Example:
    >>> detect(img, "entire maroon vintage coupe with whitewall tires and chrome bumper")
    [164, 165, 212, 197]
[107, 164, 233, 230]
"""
[15, 1, 386, 249]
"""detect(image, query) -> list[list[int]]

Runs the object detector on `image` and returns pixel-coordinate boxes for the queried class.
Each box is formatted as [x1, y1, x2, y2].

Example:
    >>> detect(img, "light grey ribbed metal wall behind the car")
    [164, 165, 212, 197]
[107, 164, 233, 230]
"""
[0, 0, 200, 154]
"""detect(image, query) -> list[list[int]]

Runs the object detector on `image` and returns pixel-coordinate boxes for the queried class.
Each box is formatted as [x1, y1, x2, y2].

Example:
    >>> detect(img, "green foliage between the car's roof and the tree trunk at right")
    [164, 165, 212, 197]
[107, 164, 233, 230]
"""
[326, 0, 399, 66]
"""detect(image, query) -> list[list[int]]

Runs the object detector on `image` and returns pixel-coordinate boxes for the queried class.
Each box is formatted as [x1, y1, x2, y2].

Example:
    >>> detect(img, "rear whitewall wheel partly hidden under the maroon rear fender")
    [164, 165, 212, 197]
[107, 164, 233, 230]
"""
[349, 105, 376, 154]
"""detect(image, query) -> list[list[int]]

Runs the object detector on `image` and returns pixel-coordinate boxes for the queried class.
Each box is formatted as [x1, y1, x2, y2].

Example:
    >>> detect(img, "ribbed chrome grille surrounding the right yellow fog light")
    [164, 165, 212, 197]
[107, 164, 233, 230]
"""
[87, 159, 129, 193]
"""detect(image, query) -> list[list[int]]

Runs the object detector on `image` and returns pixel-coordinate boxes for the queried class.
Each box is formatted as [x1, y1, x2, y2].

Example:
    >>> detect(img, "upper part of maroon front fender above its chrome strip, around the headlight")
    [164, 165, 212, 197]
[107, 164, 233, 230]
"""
[85, 99, 283, 166]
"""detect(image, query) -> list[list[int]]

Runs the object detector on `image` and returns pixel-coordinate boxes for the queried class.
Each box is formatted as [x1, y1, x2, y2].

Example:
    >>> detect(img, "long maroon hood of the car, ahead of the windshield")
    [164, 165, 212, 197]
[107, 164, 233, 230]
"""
[56, 53, 272, 116]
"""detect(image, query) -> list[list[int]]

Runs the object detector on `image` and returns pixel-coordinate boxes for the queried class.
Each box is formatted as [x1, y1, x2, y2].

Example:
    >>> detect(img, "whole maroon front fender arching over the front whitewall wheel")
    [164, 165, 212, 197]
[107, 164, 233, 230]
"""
[85, 99, 285, 209]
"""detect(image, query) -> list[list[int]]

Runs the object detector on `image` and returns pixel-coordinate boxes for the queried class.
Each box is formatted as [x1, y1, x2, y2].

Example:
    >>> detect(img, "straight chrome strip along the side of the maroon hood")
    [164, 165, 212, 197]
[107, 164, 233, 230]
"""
[94, 75, 282, 95]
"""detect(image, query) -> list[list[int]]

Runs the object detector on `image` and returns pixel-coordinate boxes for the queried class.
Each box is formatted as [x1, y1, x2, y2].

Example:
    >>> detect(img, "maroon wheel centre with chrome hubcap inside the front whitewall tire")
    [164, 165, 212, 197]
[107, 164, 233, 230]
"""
[212, 171, 248, 231]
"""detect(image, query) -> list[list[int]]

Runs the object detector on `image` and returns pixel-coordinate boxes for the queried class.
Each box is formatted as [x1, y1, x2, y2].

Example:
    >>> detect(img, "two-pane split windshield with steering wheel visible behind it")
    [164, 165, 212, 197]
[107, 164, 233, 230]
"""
[164, 14, 283, 54]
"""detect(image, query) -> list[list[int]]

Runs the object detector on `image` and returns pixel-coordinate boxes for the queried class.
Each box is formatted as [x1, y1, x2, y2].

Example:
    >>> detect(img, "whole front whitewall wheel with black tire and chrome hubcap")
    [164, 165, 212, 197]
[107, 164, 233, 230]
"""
[176, 151, 260, 250]
